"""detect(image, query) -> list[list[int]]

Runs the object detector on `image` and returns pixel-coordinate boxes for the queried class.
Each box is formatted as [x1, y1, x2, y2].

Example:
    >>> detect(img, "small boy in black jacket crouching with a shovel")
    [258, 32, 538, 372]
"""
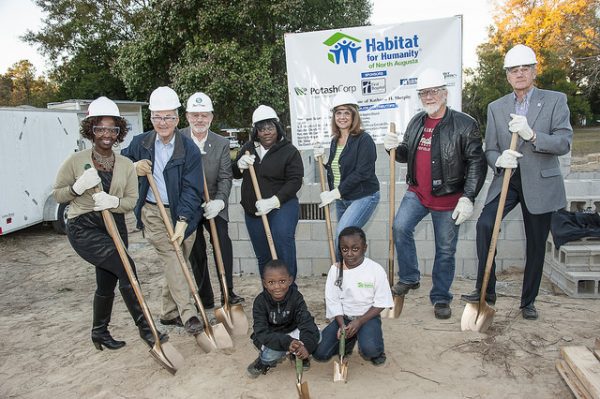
[248, 260, 320, 378]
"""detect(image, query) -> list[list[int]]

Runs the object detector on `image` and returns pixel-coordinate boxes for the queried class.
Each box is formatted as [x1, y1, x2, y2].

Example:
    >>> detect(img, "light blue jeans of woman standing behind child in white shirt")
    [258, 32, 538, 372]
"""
[334, 191, 380, 261]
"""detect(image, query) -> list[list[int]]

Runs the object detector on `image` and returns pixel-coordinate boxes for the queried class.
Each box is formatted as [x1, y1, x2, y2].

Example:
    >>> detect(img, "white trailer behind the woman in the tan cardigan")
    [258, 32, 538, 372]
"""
[0, 107, 80, 235]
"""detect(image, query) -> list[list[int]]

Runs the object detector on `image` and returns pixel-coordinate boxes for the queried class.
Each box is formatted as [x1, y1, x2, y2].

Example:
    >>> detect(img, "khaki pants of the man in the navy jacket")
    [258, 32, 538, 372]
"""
[142, 203, 198, 324]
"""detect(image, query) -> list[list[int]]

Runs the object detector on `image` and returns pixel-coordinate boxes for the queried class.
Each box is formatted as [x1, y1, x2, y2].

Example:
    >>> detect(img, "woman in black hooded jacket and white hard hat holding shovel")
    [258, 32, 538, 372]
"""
[233, 105, 304, 280]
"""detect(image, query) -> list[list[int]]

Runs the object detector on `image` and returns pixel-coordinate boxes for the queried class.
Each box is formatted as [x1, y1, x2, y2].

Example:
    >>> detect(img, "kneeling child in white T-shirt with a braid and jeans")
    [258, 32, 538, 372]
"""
[313, 226, 394, 366]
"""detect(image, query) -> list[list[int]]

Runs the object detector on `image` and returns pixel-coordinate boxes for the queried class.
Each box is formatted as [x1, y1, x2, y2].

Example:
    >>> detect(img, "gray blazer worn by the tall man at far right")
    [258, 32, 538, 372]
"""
[485, 87, 573, 215]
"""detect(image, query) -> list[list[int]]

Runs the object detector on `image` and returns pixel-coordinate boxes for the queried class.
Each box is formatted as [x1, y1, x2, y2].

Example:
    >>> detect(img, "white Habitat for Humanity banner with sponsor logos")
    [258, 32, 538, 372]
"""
[285, 15, 462, 149]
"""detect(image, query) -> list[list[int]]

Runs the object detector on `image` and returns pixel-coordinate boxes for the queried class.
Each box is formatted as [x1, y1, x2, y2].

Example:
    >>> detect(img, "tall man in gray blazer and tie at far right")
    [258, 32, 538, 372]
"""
[462, 44, 573, 320]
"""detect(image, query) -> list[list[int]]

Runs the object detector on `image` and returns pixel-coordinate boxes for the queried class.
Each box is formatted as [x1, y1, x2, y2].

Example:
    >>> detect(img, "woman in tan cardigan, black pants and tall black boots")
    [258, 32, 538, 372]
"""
[53, 97, 166, 350]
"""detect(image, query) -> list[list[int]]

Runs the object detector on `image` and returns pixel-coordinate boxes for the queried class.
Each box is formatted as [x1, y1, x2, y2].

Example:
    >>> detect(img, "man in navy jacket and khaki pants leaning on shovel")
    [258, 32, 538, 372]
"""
[121, 86, 203, 334]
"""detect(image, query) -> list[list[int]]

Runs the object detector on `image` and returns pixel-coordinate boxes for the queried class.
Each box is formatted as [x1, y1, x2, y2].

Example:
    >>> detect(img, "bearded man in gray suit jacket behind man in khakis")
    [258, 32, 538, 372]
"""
[181, 93, 244, 309]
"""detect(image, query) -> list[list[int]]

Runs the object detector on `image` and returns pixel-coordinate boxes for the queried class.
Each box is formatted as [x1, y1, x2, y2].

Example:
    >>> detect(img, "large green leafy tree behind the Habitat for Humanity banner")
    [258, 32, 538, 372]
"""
[117, 0, 371, 126]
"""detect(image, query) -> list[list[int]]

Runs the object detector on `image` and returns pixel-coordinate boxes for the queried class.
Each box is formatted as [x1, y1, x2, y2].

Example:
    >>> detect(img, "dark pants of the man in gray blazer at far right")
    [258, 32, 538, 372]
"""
[476, 169, 552, 307]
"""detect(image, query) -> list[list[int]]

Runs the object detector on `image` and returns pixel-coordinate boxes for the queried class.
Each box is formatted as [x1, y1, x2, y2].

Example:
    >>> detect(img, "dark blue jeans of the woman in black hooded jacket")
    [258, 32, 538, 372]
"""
[245, 198, 300, 280]
